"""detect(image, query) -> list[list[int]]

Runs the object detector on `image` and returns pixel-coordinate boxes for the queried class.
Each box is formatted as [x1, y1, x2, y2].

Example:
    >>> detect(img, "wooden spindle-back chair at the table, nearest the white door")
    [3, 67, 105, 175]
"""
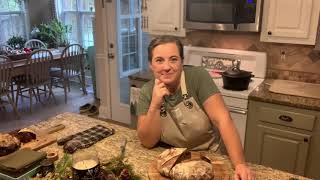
[51, 44, 87, 103]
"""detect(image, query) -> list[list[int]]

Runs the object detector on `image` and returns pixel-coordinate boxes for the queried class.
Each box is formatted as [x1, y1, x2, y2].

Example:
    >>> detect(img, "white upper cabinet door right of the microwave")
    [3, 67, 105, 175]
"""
[260, 0, 320, 45]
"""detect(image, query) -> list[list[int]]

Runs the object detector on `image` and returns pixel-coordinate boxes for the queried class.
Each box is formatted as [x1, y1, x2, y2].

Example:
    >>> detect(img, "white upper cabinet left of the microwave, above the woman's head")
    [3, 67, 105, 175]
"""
[141, 0, 186, 37]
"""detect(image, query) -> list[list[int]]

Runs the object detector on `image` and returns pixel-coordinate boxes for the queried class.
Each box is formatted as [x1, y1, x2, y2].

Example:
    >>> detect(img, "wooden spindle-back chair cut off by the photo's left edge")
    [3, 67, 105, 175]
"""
[0, 55, 20, 118]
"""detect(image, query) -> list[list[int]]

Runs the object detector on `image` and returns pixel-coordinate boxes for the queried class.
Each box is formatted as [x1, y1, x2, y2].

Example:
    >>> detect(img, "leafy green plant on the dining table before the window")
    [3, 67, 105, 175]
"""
[33, 19, 71, 48]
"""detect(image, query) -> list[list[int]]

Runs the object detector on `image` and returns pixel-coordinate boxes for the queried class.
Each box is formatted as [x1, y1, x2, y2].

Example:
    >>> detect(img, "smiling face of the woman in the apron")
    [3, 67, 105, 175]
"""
[149, 43, 183, 86]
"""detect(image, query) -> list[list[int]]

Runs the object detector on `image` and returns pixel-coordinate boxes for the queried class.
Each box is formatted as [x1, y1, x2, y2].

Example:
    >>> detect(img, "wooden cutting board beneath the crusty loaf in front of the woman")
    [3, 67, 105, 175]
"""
[148, 156, 232, 180]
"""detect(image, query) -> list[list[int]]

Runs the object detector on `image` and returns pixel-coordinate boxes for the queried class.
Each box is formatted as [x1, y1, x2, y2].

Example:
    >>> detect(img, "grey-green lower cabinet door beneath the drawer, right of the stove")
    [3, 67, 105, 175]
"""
[257, 124, 310, 175]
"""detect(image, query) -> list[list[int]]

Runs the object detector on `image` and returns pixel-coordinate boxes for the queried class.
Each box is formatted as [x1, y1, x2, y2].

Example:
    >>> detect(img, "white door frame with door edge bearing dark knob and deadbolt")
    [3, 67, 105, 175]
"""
[95, 0, 131, 124]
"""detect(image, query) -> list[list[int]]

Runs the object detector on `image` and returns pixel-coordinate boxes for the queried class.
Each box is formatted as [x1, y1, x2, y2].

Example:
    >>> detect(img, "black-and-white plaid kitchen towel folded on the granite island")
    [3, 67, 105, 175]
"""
[58, 125, 114, 153]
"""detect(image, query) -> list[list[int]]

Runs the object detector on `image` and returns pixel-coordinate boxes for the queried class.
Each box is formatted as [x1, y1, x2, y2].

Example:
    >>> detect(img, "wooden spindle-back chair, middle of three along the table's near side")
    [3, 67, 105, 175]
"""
[16, 49, 56, 112]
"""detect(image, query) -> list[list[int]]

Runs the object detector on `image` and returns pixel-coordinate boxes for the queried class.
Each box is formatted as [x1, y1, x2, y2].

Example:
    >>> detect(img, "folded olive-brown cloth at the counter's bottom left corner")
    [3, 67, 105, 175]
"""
[0, 149, 46, 172]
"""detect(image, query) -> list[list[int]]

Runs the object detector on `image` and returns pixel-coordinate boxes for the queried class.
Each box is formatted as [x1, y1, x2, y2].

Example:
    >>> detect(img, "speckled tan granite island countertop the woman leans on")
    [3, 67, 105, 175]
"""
[30, 113, 307, 180]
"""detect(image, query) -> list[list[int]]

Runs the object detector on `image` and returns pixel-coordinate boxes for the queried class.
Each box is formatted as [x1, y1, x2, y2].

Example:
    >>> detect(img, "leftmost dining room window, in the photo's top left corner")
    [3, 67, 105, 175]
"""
[0, 0, 27, 44]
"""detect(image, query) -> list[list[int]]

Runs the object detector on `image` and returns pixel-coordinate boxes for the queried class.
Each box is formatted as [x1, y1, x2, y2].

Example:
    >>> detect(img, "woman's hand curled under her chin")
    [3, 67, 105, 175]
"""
[149, 79, 170, 109]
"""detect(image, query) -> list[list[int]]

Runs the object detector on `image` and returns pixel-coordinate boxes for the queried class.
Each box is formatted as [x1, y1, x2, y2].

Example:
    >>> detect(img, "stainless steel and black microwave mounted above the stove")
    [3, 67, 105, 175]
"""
[183, 0, 262, 32]
